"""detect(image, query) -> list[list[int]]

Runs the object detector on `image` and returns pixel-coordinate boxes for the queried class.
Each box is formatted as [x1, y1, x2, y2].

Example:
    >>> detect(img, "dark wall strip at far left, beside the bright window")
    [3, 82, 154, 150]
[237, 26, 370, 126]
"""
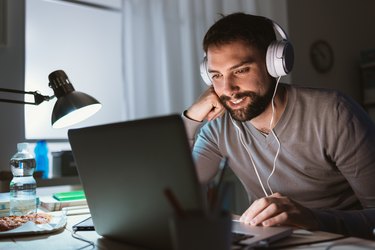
[0, 0, 25, 171]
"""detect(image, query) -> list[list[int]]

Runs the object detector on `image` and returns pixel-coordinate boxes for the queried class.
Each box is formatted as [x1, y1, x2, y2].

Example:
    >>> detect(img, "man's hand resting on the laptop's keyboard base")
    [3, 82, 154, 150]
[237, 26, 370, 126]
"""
[240, 193, 318, 230]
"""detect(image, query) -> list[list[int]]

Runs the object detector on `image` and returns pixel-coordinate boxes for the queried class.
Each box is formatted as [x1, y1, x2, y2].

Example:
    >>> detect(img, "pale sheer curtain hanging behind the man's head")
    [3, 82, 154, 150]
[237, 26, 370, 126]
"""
[122, 0, 284, 119]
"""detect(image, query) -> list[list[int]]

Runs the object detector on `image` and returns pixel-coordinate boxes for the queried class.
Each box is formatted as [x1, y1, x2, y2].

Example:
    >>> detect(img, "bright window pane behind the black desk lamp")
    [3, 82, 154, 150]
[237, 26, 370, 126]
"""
[25, 0, 125, 140]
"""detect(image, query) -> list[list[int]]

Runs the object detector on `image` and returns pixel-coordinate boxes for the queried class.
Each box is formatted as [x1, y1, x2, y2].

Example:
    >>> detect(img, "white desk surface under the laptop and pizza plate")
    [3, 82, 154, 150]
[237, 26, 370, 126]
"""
[0, 214, 375, 250]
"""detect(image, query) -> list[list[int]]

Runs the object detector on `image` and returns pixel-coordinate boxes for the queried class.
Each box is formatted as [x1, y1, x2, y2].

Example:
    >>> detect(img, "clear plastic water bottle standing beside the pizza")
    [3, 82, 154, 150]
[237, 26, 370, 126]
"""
[9, 143, 37, 215]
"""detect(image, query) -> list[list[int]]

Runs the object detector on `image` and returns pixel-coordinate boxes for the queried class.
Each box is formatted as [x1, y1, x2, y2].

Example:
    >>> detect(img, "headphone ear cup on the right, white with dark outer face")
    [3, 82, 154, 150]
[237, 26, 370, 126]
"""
[266, 40, 294, 77]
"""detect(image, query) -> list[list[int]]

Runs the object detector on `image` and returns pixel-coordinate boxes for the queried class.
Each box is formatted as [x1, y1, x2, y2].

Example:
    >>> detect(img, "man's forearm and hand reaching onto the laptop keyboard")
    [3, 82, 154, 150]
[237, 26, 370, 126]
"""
[240, 193, 375, 239]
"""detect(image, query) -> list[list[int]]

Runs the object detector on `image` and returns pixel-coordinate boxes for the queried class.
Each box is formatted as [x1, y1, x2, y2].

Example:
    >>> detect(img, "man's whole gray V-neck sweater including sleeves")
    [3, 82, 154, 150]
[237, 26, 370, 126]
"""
[183, 84, 375, 238]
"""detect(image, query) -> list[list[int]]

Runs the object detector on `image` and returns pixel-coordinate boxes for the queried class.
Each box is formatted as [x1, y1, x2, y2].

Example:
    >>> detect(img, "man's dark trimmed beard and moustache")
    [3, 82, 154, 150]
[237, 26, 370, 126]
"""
[220, 85, 275, 122]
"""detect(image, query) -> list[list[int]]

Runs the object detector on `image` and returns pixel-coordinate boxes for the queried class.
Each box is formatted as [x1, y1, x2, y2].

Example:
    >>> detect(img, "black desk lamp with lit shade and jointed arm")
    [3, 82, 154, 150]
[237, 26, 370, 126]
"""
[0, 70, 102, 128]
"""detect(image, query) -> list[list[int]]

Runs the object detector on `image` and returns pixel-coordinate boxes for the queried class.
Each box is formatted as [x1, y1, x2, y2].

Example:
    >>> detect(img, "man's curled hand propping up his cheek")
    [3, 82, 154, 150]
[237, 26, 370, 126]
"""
[186, 86, 225, 122]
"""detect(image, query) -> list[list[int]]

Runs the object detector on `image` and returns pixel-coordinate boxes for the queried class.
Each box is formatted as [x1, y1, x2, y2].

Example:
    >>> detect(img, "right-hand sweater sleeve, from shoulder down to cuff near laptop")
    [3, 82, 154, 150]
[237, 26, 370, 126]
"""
[313, 93, 375, 239]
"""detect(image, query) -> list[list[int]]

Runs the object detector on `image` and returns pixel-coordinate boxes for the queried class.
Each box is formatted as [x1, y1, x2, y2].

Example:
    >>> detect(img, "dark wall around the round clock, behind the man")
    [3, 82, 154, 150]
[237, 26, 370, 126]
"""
[287, 0, 375, 102]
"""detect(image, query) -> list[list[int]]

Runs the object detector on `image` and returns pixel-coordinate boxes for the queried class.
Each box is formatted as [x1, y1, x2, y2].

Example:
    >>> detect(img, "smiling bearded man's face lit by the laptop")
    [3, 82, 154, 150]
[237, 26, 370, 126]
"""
[207, 41, 275, 121]
